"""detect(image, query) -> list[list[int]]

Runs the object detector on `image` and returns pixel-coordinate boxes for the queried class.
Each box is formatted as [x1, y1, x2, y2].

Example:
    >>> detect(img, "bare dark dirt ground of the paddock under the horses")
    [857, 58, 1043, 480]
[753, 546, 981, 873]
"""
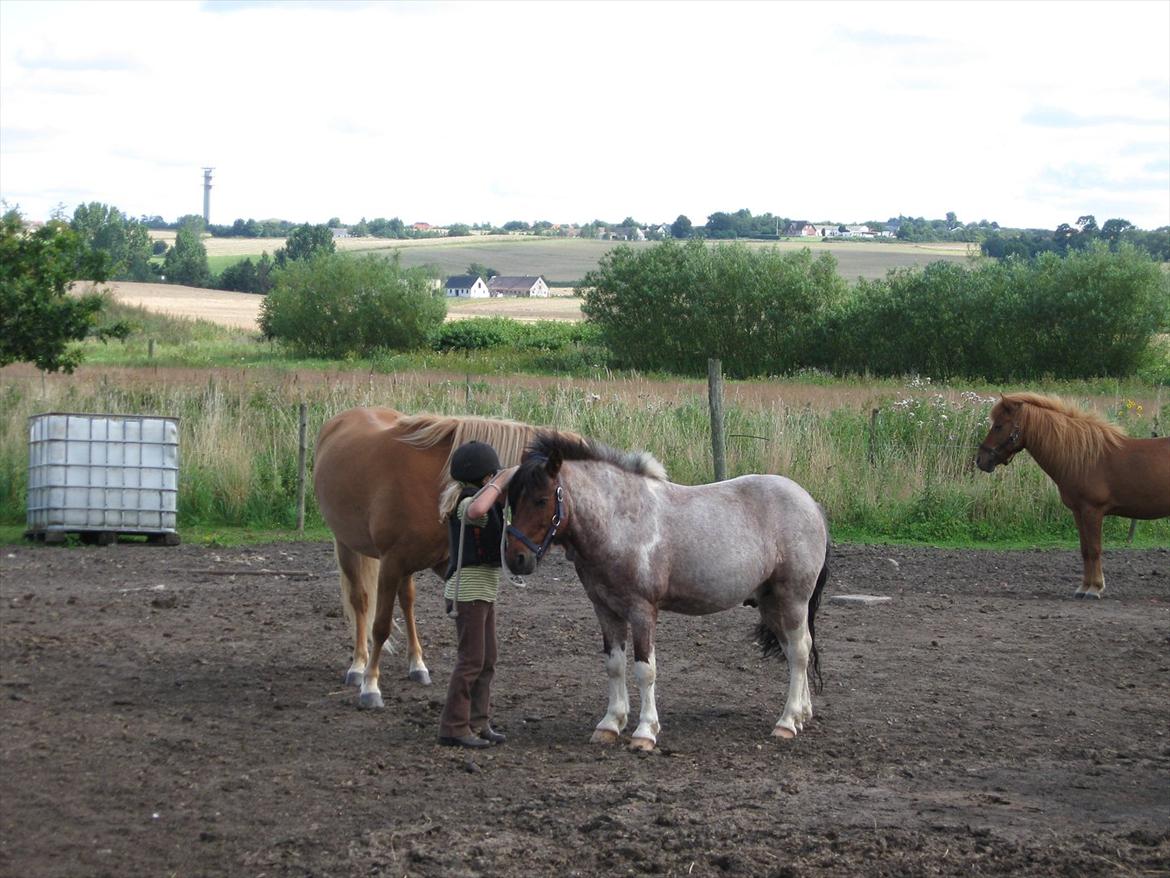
[0, 543, 1170, 878]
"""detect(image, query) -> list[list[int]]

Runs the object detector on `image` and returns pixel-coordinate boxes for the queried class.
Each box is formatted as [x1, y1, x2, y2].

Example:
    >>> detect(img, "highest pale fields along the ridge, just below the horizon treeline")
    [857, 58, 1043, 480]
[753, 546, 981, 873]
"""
[153, 232, 978, 286]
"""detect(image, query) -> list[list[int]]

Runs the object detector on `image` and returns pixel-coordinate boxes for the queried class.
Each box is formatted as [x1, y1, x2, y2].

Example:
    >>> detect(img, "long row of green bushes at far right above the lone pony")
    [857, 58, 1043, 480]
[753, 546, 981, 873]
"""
[813, 245, 1170, 382]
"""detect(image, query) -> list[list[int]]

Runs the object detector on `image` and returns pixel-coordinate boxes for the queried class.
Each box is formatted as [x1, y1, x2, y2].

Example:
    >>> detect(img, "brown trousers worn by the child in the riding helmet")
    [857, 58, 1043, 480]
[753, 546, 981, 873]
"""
[439, 601, 496, 738]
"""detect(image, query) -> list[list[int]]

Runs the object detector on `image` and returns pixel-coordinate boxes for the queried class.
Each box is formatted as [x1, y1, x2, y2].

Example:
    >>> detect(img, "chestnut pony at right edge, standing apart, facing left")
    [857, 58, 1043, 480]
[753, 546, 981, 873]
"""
[975, 393, 1170, 598]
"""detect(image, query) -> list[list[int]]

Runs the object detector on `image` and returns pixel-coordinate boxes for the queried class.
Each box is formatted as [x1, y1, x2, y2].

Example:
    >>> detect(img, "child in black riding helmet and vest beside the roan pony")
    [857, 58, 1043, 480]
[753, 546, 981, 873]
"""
[439, 441, 516, 748]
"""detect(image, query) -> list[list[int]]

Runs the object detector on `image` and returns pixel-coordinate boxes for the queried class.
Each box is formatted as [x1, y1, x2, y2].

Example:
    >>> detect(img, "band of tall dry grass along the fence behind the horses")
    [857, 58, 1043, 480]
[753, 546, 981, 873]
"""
[0, 369, 1170, 543]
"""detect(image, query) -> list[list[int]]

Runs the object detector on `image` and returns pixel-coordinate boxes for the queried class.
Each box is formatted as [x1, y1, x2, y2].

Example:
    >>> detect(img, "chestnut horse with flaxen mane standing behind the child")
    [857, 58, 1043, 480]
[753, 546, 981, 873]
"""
[312, 409, 534, 707]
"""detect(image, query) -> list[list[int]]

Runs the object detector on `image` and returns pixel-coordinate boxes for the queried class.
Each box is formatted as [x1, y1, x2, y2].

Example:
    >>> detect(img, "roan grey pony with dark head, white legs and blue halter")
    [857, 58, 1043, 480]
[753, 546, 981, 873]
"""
[504, 432, 828, 750]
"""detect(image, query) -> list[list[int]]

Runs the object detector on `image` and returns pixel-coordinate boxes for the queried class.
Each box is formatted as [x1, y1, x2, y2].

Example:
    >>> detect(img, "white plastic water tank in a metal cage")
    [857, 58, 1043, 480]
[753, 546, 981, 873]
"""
[28, 412, 179, 542]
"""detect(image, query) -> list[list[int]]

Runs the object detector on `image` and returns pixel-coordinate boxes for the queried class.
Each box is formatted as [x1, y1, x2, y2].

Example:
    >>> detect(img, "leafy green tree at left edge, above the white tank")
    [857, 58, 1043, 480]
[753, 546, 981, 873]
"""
[0, 211, 130, 372]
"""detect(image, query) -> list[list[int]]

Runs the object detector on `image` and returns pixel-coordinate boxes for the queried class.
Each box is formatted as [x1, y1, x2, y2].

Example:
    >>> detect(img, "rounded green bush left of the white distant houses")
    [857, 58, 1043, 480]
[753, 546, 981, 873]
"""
[260, 254, 447, 358]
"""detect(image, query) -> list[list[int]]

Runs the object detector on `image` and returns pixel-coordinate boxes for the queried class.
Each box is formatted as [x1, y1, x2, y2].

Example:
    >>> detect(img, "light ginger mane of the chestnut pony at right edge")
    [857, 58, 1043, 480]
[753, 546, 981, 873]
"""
[991, 392, 1126, 475]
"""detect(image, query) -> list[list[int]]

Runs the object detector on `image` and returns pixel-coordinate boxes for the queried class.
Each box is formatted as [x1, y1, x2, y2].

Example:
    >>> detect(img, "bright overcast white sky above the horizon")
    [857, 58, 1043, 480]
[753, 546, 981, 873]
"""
[0, 0, 1170, 228]
